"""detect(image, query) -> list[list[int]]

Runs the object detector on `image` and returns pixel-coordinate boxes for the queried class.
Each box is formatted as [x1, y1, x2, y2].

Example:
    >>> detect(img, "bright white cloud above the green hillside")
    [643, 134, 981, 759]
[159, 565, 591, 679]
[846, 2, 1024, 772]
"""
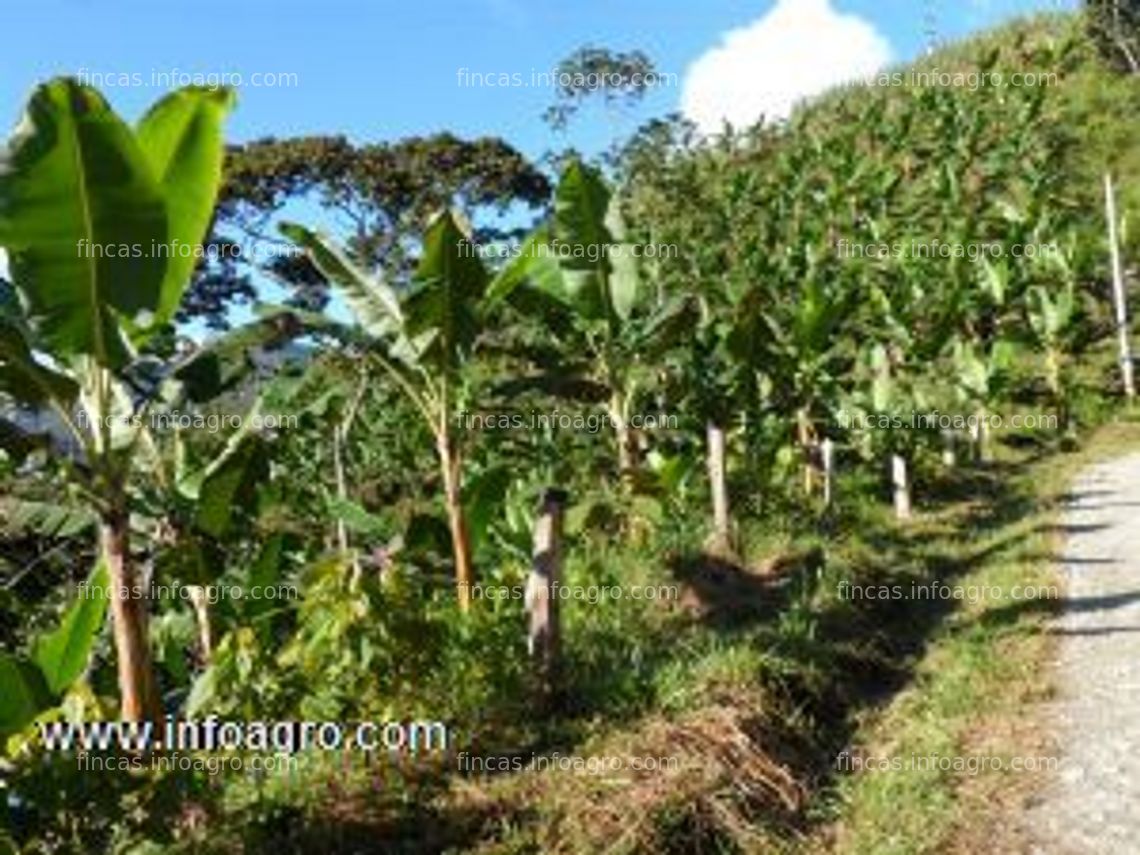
[681, 0, 890, 133]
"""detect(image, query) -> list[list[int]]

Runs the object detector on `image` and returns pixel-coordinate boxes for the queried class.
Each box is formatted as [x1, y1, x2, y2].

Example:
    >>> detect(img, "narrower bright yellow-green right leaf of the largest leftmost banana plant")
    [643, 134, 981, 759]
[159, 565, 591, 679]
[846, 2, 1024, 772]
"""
[137, 87, 235, 335]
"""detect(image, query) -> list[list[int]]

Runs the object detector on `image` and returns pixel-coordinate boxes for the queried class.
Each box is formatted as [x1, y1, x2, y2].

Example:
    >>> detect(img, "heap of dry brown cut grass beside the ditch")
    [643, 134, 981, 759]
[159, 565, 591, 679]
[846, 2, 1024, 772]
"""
[455, 697, 808, 854]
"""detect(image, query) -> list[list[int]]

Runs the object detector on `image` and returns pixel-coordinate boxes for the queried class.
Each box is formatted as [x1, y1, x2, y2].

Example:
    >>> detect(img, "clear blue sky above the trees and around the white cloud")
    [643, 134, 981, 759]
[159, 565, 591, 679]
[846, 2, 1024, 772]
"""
[0, 0, 1075, 156]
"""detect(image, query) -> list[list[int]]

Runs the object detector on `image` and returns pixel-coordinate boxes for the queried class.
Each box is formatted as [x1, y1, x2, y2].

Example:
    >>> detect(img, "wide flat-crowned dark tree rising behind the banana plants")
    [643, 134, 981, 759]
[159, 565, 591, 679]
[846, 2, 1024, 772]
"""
[179, 133, 551, 328]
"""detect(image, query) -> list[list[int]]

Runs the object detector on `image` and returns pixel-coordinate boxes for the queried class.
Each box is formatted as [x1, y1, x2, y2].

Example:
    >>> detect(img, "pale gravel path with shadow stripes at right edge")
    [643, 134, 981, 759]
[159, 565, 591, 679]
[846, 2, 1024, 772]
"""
[1026, 455, 1140, 855]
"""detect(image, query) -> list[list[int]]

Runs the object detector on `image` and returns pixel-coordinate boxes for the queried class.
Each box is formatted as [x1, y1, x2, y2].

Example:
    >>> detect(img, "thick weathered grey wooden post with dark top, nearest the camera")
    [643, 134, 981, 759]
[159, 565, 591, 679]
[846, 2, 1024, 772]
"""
[526, 488, 569, 700]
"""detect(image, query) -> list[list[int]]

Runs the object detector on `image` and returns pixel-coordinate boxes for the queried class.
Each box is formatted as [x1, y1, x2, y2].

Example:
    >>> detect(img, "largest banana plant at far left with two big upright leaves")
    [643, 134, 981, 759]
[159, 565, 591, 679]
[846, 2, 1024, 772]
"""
[0, 79, 234, 720]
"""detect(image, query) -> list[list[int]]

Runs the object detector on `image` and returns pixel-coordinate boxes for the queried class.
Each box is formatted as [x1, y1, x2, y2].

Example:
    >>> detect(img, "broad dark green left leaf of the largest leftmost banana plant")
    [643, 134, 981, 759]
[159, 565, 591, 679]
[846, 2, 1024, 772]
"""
[0, 79, 168, 367]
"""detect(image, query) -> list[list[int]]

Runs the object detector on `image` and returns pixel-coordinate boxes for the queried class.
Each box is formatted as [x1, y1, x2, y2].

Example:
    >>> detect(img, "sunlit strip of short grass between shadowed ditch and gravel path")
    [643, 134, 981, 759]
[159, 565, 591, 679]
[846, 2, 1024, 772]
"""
[800, 421, 1140, 854]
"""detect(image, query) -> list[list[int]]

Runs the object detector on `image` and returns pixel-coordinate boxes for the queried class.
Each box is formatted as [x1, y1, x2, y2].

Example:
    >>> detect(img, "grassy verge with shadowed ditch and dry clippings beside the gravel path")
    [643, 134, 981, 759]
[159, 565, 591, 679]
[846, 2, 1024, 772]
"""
[186, 412, 1140, 855]
